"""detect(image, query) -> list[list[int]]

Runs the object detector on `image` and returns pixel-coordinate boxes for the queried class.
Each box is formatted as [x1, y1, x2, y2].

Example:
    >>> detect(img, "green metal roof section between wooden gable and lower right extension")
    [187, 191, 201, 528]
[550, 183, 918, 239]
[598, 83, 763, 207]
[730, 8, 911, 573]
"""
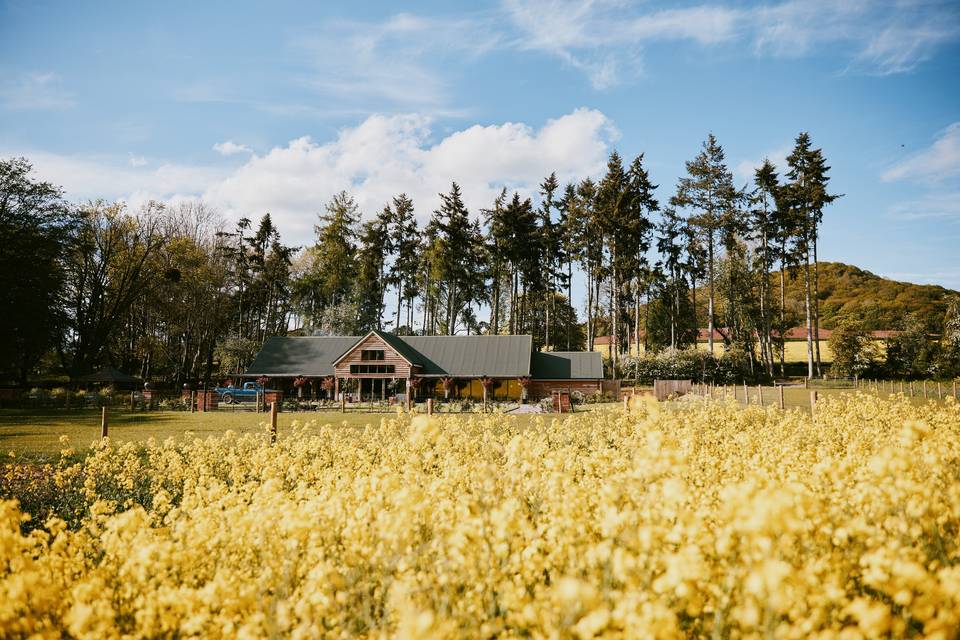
[398, 336, 533, 378]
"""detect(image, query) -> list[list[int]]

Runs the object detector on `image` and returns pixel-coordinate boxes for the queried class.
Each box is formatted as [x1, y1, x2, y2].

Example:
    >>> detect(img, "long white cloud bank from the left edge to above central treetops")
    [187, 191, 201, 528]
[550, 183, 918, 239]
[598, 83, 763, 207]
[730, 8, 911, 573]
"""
[0, 109, 618, 244]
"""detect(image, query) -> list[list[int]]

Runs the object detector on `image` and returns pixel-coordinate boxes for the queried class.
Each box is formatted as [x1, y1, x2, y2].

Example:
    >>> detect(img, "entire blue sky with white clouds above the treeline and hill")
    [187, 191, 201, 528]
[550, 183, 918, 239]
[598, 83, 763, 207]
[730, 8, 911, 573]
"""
[0, 0, 960, 289]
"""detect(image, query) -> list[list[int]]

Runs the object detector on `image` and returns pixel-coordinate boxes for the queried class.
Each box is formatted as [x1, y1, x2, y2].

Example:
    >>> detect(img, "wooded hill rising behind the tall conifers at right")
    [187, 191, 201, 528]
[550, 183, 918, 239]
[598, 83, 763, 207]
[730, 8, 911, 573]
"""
[774, 262, 960, 332]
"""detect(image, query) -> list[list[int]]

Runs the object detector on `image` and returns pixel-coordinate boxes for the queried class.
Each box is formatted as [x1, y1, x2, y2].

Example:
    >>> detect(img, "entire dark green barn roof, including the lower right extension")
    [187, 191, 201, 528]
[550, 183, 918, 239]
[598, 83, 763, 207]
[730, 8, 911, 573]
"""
[246, 331, 603, 380]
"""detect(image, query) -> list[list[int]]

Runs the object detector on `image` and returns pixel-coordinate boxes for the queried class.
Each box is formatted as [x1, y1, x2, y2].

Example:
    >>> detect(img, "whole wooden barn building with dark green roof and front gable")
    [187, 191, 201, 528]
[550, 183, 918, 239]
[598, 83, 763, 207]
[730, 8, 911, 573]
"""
[245, 331, 603, 400]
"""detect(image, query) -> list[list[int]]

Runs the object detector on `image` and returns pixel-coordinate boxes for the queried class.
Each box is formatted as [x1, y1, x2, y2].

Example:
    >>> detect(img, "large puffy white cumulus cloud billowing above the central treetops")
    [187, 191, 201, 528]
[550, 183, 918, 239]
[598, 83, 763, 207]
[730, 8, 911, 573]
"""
[204, 109, 616, 243]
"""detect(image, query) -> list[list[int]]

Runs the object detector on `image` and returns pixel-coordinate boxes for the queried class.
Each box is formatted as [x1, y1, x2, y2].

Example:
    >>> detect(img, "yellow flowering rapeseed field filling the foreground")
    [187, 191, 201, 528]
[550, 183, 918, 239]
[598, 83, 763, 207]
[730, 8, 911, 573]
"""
[0, 395, 960, 639]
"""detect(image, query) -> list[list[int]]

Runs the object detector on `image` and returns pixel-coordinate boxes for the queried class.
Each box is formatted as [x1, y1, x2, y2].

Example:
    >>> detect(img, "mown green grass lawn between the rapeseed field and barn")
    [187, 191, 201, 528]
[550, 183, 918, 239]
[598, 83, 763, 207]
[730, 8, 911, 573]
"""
[0, 404, 617, 459]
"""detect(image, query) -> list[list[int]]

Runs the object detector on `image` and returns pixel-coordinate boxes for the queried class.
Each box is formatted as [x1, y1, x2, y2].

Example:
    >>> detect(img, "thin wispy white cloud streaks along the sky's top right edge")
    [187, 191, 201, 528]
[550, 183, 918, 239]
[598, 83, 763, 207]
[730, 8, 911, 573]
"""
[503, 0, 960, 88]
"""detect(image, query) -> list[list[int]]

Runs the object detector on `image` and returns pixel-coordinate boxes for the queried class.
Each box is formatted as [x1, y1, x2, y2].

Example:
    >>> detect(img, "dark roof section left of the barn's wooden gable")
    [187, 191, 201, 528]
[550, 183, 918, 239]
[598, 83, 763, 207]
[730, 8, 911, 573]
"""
[245, 336, 360, 378]
